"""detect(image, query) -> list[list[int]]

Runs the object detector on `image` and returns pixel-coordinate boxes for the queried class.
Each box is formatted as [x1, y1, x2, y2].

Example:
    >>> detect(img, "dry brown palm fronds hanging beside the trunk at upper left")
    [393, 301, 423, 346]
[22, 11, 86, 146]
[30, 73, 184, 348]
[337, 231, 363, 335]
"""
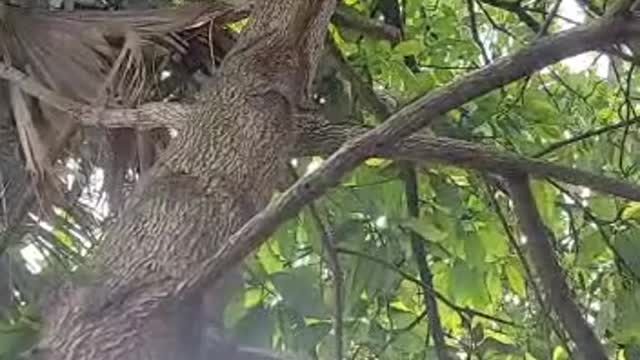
[0, 2, 247, 217]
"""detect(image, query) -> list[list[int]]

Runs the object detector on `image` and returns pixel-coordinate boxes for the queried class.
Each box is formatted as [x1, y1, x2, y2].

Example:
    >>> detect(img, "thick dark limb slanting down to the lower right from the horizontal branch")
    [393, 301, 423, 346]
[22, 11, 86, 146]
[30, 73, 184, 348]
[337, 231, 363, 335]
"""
[506, 175, 607, 360]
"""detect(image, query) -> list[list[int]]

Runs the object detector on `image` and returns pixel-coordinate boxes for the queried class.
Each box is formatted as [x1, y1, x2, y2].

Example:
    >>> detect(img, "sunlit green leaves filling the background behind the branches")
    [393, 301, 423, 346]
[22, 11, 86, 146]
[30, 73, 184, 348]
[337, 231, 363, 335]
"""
[0, 0, 640, 360]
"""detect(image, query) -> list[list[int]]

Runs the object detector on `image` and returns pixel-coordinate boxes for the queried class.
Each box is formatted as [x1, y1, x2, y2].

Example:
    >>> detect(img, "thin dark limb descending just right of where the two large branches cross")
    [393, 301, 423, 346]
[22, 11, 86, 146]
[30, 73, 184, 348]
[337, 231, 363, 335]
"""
[404, 168, 450, 360]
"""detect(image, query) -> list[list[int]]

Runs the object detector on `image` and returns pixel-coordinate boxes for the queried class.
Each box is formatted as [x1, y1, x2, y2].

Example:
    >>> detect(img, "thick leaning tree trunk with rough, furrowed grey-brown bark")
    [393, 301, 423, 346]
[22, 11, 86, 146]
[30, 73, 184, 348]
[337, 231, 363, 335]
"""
[38, 0, 335, 360]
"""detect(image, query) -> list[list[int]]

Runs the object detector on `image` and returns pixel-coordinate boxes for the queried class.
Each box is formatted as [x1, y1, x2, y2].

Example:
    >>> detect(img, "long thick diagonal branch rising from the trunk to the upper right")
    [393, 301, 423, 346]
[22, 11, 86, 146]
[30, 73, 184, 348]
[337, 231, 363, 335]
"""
[185, 13, 638, 304]
